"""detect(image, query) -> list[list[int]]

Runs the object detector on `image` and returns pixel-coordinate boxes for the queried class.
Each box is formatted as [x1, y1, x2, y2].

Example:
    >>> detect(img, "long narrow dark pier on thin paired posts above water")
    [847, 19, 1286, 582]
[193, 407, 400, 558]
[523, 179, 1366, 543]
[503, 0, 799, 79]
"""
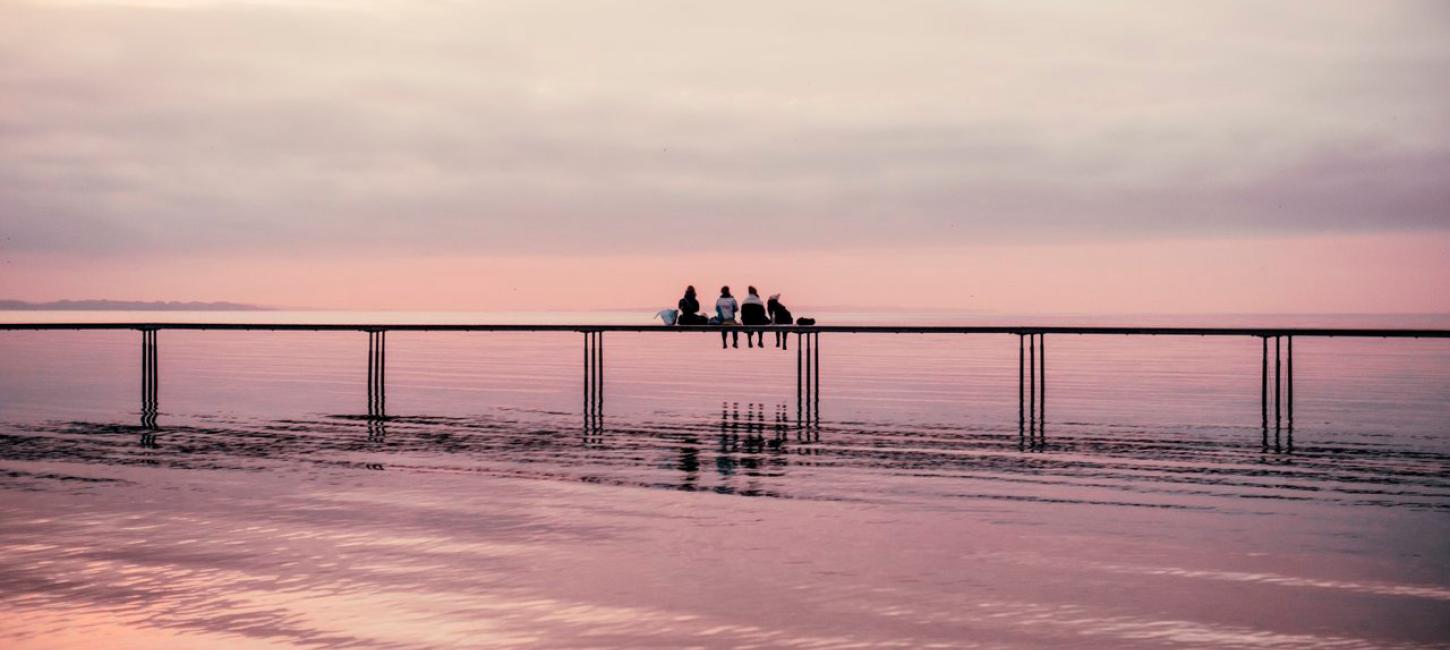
[0, 322, 1450, 451]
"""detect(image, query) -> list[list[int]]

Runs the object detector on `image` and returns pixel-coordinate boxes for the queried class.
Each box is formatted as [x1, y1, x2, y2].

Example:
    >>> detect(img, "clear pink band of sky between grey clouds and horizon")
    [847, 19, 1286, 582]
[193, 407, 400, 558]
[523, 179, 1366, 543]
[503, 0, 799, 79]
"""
[0, 235, 1450, 313]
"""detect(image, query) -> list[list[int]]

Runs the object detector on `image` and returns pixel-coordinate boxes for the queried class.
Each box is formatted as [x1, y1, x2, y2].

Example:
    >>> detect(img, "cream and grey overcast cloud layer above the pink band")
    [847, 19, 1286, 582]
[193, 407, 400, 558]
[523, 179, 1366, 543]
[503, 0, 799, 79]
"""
[0, 0, 1450, 255]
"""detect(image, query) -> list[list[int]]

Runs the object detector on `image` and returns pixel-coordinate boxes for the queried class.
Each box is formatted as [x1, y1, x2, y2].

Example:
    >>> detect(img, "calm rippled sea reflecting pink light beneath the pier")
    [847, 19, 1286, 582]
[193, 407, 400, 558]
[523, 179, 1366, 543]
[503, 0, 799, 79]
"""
[0, 310, 1450, 649]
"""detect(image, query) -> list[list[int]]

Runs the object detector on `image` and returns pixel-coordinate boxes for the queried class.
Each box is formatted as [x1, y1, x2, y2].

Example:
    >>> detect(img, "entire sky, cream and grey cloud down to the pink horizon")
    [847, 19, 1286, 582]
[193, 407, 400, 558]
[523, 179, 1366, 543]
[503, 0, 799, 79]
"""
[0, 0, 1450, 313]
